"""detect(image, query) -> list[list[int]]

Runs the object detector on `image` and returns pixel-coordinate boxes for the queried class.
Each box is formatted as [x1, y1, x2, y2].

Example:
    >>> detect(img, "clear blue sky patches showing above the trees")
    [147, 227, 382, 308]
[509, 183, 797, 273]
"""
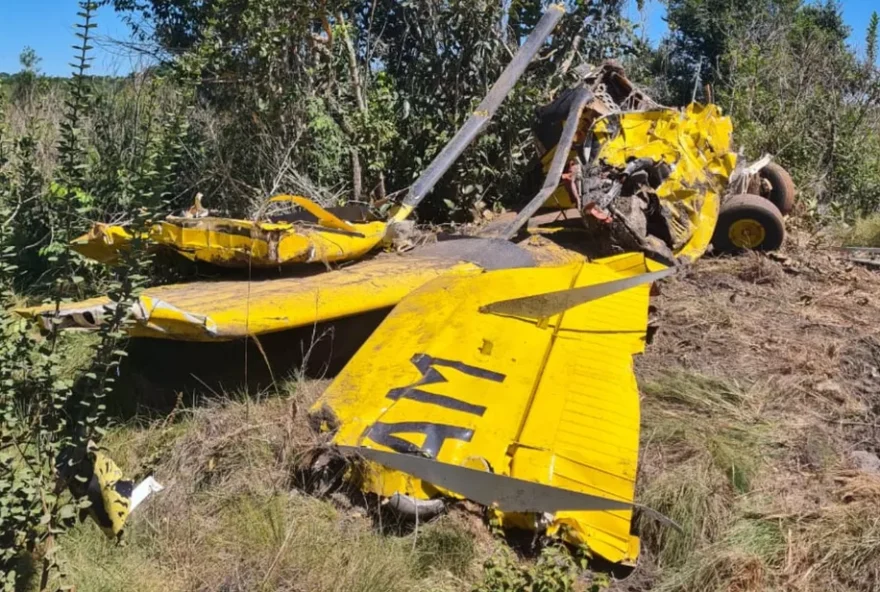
[0, 0, 880, 76]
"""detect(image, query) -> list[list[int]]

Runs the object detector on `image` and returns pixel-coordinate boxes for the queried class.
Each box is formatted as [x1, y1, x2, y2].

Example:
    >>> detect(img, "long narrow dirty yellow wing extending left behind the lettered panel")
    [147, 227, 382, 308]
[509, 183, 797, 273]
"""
[16, 239, 583, 341]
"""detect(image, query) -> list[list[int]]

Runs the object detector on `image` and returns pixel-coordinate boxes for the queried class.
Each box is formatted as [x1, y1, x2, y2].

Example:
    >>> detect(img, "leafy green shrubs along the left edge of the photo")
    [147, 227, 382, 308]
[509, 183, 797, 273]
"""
[0, 0, 187, 592]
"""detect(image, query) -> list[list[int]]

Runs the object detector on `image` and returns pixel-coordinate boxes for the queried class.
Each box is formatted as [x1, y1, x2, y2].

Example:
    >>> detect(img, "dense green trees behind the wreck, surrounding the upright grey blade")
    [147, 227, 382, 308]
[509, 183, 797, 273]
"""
[108, 0, 629, 214]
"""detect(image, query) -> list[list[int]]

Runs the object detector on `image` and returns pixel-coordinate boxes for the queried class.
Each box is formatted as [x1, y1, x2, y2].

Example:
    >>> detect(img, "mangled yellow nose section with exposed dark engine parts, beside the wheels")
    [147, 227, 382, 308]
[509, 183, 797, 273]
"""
[524, 63, 736, 264]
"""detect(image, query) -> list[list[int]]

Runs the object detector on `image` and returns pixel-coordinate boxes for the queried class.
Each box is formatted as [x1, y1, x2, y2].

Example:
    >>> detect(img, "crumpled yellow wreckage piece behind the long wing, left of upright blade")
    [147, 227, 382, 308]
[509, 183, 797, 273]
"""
[71, 196, 386, 268]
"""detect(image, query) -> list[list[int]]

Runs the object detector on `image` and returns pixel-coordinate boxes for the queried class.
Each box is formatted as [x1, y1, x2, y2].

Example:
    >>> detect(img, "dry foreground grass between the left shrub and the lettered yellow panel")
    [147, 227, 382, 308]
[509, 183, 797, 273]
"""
[53, 381, 485, 592]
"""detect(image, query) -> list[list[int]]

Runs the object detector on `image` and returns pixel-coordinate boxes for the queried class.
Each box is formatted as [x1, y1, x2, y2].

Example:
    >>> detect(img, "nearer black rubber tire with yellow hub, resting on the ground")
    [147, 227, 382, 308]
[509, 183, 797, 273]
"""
[712, 194, 785, 253]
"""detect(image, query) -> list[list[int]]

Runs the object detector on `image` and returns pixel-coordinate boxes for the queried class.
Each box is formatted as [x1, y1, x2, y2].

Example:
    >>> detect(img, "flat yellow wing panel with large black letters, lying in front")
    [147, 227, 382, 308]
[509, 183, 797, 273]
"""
[311, 254, 671, 562]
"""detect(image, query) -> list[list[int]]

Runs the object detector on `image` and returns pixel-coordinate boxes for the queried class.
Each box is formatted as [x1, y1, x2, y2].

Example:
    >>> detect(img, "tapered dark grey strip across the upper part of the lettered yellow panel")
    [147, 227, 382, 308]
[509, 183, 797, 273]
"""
[480, 267, 675, 319]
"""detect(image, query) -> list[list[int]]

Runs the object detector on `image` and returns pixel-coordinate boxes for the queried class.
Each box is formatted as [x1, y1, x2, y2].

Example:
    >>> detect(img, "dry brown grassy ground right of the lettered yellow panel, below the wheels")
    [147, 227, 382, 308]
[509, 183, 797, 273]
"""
[628, 237, 880, 591]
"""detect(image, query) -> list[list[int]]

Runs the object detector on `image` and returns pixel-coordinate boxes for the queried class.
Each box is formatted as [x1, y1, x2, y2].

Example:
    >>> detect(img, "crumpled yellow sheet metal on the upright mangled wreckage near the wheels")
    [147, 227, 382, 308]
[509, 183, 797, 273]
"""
[595, 103, 736, 261]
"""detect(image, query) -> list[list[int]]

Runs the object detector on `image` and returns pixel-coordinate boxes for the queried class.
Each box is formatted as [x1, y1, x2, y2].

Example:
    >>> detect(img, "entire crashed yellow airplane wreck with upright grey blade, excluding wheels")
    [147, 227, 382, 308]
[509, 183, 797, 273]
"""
[21, 6, 768, 563]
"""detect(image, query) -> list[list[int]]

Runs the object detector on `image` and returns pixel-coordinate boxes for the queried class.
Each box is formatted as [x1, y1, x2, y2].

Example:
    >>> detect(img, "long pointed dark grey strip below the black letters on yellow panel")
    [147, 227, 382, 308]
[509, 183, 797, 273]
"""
[339, 446, 632, 513]
